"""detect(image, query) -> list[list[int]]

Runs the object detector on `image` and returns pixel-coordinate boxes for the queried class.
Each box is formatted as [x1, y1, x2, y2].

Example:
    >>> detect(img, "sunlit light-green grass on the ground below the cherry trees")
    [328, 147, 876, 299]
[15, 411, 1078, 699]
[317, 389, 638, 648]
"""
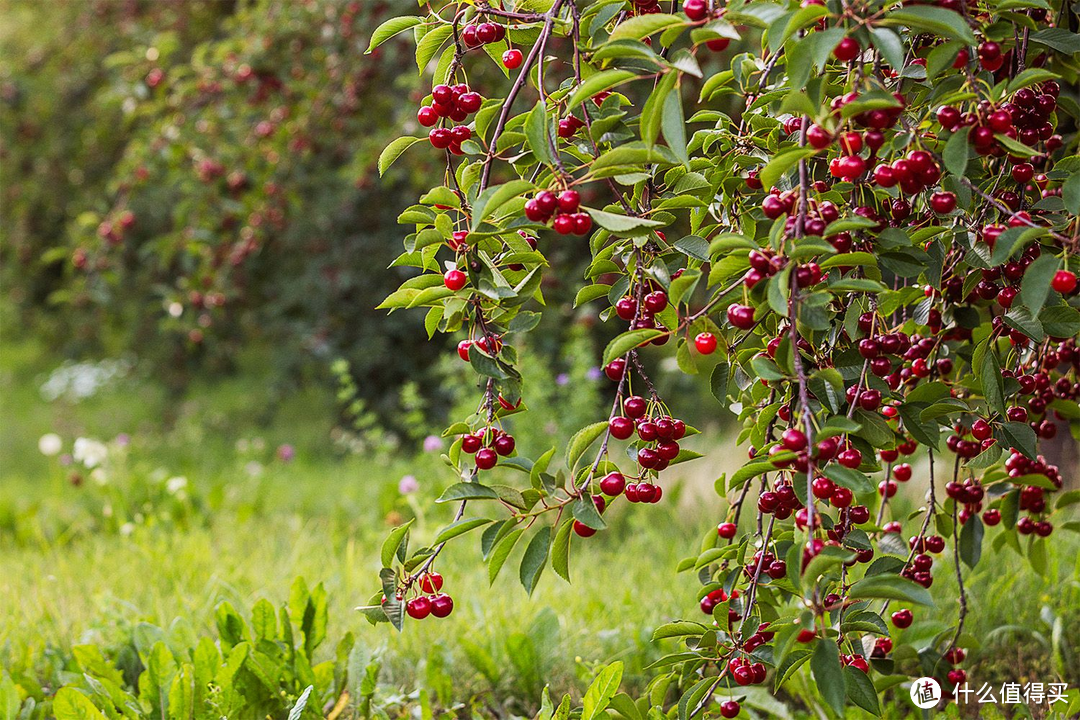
[0, 334, 1080, 712]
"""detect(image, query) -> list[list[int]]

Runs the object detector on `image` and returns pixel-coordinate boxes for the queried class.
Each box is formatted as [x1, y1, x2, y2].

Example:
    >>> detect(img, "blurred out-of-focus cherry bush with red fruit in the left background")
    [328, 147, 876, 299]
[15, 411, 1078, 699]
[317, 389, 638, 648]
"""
[0, 0, 462, 423]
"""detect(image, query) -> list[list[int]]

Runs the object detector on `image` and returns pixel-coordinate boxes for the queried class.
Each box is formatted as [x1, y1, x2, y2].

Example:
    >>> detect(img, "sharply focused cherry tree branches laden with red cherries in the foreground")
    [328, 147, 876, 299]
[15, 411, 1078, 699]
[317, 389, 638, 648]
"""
[364, 0, 1080, 720]
